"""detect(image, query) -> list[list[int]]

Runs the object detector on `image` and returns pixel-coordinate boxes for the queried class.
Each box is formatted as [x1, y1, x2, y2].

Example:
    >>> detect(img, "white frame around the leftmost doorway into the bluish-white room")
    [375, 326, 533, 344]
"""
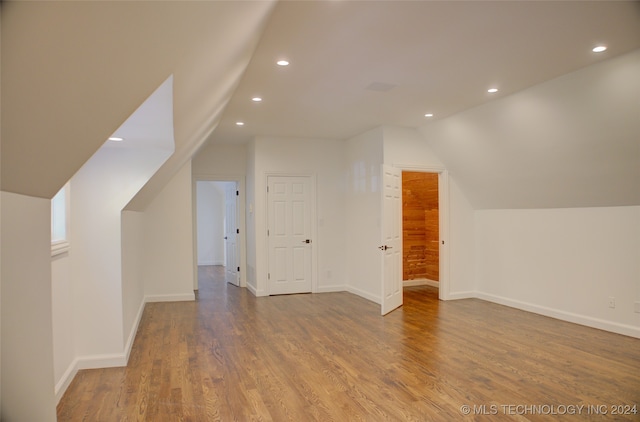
[191, 174, 247, 290]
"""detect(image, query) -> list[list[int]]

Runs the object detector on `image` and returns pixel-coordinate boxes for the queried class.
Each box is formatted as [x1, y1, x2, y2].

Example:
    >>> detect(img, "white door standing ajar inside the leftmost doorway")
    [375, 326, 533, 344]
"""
[224, 182, 240, 286]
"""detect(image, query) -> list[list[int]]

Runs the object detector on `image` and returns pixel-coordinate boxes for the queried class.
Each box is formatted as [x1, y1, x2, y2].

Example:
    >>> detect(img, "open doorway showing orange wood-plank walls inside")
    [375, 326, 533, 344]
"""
[402, 171, 441, 288]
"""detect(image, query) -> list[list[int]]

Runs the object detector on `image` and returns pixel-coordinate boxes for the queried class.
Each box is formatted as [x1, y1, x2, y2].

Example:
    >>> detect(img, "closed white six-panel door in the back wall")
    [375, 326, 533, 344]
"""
[267, 176, 313, 295]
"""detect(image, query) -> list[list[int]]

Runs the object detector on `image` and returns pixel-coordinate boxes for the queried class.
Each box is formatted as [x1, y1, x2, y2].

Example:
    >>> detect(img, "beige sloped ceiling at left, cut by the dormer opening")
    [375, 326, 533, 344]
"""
[1, 1, 274, 204]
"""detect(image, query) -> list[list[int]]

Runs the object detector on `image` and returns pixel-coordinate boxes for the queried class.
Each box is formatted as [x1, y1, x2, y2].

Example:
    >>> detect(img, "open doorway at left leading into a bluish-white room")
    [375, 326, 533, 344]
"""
[195, 180, 241, 292]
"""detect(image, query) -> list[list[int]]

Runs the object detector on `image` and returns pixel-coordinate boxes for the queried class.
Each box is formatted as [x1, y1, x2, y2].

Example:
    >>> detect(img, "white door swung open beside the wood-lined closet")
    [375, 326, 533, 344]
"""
[379, 165, 402, 315]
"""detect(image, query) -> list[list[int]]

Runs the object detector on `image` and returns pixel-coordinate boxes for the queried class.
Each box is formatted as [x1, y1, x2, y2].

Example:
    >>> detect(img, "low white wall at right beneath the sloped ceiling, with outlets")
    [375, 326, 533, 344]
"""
[475, 207, 640, 337]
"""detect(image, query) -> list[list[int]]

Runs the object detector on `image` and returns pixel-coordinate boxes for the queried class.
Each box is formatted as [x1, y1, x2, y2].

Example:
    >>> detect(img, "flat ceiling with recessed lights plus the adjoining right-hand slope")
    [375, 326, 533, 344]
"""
[209, 1, 640, 208]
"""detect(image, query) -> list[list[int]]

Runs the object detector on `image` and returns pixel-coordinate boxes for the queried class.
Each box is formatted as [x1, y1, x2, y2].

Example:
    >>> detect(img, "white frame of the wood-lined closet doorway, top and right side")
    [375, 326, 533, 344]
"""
[394, 164, 451, 300]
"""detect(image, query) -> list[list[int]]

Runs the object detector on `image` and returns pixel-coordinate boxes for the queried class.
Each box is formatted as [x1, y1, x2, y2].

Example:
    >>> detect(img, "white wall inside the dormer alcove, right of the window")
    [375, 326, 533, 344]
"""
[69, 144, 171, 367]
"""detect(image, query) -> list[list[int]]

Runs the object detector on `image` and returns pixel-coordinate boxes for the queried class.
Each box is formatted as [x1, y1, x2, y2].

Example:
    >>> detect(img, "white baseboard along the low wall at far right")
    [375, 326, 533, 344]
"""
[476, 292, 640, 338]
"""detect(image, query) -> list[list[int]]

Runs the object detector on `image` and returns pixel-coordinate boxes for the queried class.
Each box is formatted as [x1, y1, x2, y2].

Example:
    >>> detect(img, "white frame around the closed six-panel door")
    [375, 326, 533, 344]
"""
[263, 172, 319, 296]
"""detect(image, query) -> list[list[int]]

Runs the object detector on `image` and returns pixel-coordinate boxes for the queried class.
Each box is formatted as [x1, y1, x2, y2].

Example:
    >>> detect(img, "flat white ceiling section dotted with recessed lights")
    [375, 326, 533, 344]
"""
[209, 1, 640, 142]
